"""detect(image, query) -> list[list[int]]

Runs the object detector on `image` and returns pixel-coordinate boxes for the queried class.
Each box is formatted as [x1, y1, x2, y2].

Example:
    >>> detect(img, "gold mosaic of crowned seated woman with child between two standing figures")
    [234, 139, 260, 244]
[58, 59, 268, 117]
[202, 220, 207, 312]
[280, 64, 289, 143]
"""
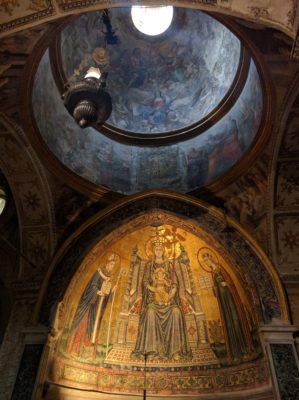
[51, 213, 267, 394]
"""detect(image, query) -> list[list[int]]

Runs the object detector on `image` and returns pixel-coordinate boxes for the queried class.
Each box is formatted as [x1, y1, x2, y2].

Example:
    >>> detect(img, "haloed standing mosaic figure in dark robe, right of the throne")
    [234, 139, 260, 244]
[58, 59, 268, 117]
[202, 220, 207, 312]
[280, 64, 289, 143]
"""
[202, 253, 253, 361]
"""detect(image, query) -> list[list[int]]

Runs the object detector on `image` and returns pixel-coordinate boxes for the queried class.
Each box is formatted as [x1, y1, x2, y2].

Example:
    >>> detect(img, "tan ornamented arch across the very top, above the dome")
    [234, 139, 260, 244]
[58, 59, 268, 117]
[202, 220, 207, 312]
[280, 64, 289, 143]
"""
[0, 0, 298, 37]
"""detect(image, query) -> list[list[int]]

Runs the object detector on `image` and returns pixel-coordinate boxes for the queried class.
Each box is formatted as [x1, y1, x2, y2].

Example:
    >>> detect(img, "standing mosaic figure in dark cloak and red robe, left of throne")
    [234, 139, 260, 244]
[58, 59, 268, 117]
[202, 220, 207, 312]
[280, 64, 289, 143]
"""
[66, 253, 119, 356]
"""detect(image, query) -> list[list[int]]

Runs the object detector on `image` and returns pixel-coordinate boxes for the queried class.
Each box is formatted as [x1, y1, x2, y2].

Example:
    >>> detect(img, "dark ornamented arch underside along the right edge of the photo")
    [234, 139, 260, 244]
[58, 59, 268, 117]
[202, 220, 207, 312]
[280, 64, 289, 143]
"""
[269, 73, 299, 281]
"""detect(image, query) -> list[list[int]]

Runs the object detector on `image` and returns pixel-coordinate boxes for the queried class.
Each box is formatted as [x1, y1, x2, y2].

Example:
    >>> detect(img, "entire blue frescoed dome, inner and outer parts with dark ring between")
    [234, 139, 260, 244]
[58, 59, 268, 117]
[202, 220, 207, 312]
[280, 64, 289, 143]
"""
[32, 8, 263, 194]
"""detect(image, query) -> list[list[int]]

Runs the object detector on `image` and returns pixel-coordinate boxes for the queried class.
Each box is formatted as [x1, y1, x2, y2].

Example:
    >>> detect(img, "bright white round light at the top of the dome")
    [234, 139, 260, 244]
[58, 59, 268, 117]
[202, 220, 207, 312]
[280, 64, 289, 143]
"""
[131, 6, 173, 36]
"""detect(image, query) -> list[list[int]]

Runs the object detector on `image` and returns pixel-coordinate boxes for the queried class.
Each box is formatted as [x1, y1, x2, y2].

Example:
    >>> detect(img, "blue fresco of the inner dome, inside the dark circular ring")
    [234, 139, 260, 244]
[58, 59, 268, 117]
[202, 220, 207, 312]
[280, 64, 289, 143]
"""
[61, 8, 241, 134]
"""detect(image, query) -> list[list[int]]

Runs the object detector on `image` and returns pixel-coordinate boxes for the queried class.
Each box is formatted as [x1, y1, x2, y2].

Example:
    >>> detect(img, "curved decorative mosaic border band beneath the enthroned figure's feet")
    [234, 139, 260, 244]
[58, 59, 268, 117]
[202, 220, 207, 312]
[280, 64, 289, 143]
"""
[52, 358, 270, 395]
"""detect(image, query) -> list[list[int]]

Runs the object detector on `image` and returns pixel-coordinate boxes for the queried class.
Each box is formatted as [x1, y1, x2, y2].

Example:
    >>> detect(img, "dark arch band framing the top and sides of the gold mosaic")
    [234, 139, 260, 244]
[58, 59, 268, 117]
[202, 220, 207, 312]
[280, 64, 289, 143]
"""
[35, 190, 289, 324]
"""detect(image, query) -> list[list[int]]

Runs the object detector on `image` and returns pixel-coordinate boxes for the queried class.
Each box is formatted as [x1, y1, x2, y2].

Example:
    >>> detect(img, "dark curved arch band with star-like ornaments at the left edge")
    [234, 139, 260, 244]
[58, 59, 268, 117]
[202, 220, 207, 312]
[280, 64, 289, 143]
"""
[0, 113, 56, 281]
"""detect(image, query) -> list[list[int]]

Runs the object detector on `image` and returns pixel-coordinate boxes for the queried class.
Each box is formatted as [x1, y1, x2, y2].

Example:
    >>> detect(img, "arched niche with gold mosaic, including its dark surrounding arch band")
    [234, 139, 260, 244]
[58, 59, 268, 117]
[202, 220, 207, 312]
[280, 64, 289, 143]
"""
[36, 191, 289, 399]
